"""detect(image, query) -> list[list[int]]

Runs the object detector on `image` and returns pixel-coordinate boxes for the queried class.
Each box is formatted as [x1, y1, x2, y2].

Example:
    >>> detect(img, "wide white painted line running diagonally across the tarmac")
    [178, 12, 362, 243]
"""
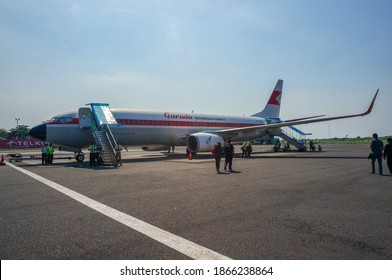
[7, 163, 230, 260]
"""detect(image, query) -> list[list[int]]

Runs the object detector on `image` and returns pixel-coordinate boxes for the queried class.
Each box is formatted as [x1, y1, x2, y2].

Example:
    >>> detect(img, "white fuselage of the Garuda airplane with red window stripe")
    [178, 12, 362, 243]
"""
[46, 109, 266, 148]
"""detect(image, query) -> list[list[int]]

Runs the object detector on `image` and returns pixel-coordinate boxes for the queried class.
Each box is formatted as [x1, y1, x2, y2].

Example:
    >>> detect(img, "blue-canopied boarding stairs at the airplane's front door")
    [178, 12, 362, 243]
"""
[88, 103, 117, 166]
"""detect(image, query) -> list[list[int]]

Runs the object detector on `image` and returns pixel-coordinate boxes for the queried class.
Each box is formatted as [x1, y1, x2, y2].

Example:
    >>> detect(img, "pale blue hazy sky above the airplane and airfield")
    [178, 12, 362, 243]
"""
[0, 0, 392, 138]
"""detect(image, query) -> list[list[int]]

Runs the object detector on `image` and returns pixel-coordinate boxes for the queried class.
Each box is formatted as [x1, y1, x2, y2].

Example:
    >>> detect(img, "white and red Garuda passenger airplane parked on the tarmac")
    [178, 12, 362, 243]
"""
[29, 80, 379, 161]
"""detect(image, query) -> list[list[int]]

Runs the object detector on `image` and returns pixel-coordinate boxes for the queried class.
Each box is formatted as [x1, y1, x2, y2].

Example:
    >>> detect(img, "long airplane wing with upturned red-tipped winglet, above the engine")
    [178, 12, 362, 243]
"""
[215, 89, 378, 138]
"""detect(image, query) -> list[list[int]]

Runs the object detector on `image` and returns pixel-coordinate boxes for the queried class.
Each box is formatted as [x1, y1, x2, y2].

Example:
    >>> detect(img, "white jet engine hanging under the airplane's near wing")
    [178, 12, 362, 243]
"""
[187, 132, 225, 153]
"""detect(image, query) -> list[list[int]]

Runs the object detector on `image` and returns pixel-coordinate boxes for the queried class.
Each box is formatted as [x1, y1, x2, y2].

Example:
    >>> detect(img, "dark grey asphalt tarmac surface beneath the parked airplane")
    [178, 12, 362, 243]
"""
[0, 145, 392, 260]
